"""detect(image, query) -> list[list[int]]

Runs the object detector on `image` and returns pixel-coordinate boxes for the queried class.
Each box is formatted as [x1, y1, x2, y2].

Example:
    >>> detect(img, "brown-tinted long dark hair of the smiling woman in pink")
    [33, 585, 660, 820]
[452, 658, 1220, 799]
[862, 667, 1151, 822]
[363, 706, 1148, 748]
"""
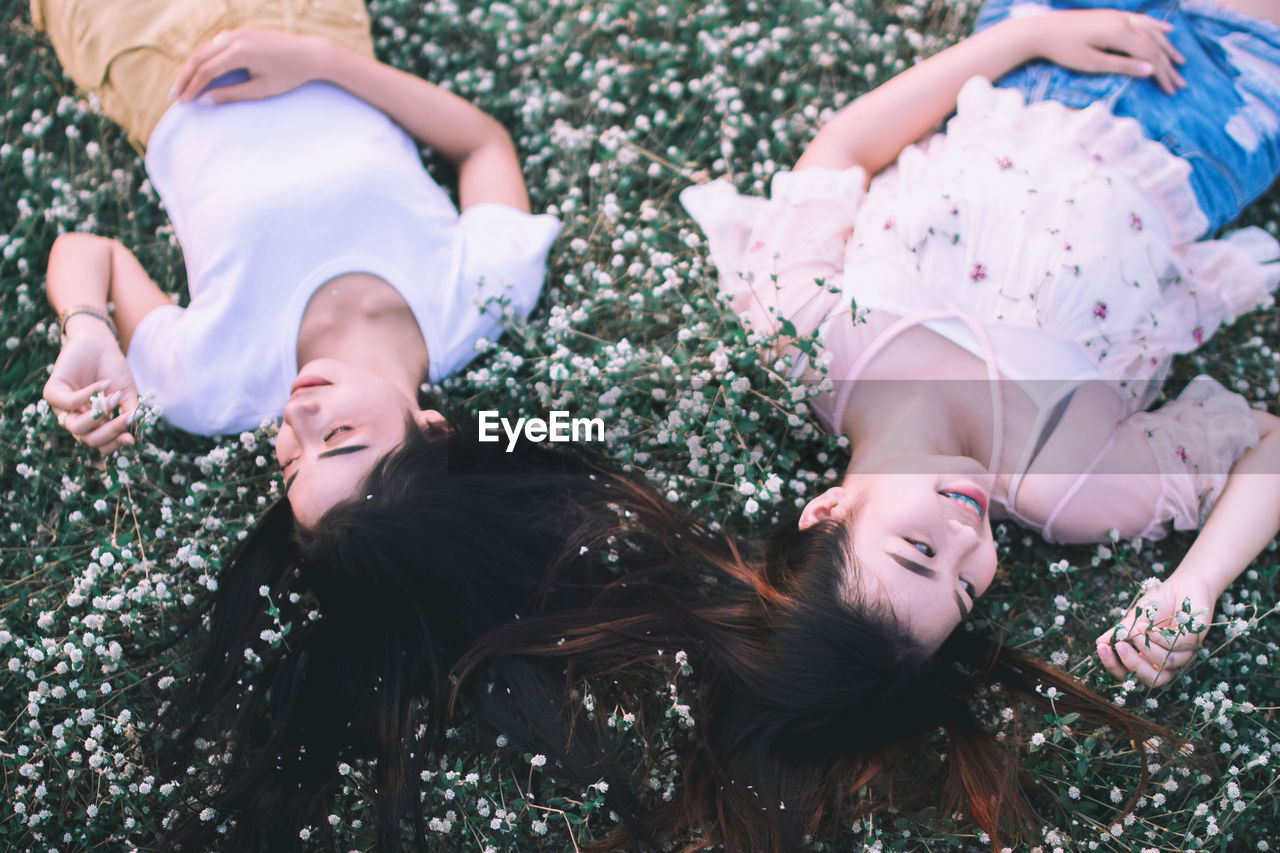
[460, 507, 1176, 852]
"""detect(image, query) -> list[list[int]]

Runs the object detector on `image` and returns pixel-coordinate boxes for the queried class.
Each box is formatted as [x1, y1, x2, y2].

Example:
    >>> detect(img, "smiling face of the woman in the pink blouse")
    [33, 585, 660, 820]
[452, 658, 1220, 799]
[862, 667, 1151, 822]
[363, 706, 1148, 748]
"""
[800, 466, 996, 649]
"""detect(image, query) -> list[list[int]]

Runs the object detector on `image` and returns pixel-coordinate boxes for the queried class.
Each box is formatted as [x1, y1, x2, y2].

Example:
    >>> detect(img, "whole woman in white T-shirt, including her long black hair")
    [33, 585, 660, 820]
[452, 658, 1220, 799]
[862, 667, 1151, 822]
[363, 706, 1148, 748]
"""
[32, 0, 565, 850]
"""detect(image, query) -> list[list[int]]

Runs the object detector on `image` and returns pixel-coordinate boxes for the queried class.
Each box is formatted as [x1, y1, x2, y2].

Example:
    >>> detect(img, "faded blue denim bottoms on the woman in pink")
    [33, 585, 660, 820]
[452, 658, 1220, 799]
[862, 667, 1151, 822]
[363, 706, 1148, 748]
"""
[978, 0, 1280, 233]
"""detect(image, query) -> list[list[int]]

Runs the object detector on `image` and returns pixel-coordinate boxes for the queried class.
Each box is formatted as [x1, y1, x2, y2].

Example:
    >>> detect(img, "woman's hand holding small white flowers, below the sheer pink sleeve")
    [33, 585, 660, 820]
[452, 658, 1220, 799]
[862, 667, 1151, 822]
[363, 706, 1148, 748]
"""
[1097, 571, 1217, 686]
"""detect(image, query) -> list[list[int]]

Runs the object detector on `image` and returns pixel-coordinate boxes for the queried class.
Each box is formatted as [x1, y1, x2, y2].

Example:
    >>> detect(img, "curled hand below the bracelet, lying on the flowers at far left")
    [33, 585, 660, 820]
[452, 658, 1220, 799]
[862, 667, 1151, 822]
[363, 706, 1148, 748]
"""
[45, 316, 138, 456]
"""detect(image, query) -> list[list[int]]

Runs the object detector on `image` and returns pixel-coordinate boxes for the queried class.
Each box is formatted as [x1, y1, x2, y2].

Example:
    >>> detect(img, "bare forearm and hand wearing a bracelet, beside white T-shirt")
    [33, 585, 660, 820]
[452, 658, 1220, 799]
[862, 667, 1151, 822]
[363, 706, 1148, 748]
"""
[45, 233, 170, 453]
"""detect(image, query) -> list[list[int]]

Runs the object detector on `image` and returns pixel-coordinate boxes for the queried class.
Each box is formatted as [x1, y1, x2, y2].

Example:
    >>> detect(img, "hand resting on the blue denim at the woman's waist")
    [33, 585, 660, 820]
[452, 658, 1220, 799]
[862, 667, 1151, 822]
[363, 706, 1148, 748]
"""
[1021, 9, 1187, 95]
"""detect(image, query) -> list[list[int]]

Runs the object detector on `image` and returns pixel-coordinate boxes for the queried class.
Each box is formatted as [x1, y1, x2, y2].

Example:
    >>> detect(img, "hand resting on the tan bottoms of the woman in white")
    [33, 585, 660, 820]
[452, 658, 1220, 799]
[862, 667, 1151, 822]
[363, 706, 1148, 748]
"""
[172, 27, 324, 104]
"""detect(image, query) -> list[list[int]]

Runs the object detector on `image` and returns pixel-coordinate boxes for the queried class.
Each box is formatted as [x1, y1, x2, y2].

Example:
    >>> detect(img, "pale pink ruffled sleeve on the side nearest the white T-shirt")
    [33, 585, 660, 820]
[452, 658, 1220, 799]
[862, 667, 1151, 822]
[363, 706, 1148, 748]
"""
[680, 167, 867, 336]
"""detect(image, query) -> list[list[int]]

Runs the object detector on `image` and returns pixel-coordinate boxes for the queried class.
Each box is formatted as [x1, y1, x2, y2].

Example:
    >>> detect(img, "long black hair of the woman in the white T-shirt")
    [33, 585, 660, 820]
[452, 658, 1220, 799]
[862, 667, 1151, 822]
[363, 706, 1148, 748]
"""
[161, 414, 627, 850]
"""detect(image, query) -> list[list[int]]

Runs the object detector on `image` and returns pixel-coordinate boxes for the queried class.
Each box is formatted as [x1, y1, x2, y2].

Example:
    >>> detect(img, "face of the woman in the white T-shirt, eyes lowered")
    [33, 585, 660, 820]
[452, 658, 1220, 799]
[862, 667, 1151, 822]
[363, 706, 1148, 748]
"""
[275, 359, 444, 528]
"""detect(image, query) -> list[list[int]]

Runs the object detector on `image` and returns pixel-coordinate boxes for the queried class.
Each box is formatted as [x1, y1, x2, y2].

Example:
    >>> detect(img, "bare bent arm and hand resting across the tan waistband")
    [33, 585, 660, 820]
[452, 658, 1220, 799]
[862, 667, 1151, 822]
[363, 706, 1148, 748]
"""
[174, 28, 529, 211]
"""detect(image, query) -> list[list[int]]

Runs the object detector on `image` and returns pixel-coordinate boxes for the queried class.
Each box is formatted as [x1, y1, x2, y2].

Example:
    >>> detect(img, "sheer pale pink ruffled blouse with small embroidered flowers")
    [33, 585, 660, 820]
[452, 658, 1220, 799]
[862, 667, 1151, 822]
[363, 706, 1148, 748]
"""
[681, 78, 1280, 542]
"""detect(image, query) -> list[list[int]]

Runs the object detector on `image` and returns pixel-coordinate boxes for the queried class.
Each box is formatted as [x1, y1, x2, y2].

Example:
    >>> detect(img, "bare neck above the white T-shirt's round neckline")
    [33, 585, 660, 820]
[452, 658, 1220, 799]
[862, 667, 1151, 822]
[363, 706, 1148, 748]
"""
[297, 273, 429, 400]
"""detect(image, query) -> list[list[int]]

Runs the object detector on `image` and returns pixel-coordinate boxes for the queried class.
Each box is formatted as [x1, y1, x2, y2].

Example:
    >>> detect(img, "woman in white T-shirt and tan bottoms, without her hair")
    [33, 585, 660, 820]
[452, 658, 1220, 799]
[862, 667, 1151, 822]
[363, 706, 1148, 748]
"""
[33, 0, 559, 526]
